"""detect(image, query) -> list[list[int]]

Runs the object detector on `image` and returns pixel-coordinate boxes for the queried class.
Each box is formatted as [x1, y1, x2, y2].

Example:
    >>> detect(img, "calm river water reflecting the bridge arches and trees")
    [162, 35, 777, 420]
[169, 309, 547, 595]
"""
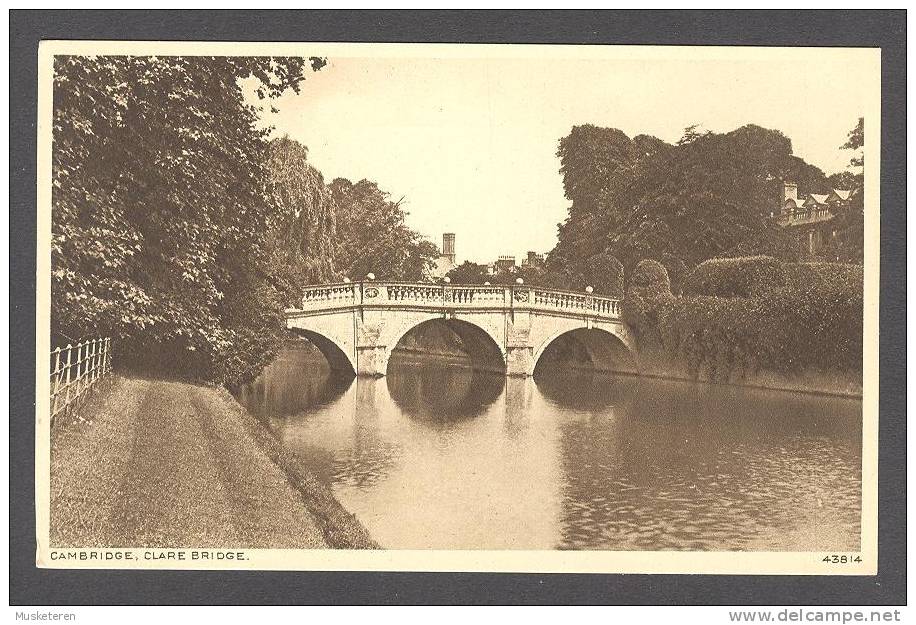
[239, 350, 861, 551]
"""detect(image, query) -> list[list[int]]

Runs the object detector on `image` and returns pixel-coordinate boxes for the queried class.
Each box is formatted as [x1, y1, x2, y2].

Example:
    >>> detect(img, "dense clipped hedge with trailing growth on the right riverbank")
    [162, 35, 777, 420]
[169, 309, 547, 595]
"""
[658, 259, 862, 381]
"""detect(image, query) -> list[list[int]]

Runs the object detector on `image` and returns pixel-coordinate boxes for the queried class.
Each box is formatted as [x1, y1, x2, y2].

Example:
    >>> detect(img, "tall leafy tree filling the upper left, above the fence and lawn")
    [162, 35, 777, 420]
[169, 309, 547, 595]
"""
[51, 56, 323, 381]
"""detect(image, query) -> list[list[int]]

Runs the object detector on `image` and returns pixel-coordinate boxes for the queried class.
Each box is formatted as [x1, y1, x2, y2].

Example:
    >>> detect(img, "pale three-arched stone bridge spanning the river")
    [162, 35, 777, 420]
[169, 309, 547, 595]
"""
[286, 281, 635, 376]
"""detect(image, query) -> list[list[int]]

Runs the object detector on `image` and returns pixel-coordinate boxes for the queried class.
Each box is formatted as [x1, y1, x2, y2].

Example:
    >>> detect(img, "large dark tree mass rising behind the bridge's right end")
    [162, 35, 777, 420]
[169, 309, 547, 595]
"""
[549, 125, 828, 275]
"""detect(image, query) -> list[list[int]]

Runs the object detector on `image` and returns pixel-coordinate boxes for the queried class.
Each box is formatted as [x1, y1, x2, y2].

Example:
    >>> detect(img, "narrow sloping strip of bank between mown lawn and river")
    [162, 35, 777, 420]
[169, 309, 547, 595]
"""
[215, 386, 381, 549]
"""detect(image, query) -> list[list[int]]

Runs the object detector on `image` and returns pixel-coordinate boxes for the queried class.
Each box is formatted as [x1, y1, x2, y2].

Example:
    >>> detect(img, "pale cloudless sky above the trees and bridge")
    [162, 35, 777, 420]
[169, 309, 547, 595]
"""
[264, 48, 870, 262]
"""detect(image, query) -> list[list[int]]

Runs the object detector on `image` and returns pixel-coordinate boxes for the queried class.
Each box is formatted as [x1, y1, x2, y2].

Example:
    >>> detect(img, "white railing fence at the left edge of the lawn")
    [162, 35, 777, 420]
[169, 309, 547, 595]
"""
[51, 338, 111, 423]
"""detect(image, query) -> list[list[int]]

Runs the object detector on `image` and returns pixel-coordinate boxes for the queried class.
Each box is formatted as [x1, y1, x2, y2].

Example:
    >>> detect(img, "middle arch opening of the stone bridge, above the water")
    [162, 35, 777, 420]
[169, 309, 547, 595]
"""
[385, 314, 506, 374]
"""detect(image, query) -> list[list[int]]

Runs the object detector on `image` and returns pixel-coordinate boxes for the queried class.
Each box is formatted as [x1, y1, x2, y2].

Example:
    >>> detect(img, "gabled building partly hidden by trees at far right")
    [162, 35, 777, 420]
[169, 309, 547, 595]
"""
[770, 182, 852, 255]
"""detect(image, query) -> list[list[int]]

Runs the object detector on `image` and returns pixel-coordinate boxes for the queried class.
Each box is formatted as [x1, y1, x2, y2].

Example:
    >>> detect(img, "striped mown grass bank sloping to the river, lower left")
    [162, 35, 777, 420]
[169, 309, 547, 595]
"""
[51, 376, 377, 549]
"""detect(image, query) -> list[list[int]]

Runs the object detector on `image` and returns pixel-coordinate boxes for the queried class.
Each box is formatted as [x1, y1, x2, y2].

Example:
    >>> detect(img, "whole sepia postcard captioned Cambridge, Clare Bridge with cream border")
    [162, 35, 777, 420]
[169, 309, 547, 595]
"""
[36, 41, 881, 575]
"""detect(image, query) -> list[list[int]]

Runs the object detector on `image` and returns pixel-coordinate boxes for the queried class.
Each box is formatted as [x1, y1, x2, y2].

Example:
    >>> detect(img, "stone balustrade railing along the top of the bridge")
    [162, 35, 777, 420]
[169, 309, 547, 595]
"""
[287, 281, 620, 319]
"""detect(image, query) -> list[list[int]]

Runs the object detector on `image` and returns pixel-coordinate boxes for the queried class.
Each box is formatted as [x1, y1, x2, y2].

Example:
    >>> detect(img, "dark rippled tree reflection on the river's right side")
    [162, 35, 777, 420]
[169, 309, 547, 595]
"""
[538, 376, 861, 551]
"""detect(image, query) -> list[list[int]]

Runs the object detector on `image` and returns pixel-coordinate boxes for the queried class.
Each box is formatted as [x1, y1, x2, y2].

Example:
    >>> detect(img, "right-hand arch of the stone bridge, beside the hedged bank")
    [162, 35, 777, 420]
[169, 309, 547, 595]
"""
[532, 326, 638, 375]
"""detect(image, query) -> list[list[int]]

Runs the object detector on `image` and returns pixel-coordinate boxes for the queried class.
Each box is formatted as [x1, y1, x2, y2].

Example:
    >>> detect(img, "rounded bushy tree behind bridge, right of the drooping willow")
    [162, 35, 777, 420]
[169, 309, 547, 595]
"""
[329, 178, 439, 281]
